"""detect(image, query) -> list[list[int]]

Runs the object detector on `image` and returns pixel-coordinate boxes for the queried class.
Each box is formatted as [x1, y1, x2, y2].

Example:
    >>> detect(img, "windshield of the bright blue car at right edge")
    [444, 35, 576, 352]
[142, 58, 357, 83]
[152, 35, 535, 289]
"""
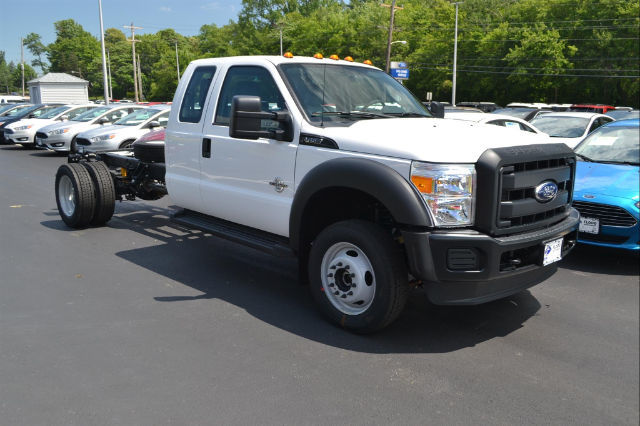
[575, 126, 640, 165]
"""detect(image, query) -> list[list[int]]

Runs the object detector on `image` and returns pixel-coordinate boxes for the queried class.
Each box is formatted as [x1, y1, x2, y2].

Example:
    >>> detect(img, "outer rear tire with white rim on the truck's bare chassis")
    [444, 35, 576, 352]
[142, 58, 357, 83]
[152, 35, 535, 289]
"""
[56, 163, 96, 228]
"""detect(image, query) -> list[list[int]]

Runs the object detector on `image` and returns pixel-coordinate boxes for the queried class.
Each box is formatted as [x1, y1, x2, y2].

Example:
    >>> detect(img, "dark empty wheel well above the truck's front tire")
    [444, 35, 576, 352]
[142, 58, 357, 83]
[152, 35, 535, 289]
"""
[299, 187, 395, 253]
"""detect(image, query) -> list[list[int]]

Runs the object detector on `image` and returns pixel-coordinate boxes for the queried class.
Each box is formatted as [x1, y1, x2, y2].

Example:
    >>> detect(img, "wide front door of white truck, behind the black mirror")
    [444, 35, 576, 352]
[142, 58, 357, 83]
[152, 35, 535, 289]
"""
[200, 65, 298, 236]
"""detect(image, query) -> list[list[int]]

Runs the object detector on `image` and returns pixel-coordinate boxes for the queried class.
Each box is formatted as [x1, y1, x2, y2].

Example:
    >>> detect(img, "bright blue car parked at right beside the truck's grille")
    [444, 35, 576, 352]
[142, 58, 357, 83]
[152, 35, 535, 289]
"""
[573, 119, 640, 251]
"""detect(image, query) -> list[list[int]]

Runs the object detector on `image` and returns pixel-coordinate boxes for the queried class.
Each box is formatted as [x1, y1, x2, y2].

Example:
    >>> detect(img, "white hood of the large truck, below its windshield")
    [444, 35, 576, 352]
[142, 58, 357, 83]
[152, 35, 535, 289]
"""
[302, 118, 555, 163]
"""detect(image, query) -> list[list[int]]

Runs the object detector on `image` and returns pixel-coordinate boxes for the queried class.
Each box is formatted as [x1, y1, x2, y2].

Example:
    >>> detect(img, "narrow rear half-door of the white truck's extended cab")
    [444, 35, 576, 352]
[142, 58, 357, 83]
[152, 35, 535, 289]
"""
[165, 64, 218, 211]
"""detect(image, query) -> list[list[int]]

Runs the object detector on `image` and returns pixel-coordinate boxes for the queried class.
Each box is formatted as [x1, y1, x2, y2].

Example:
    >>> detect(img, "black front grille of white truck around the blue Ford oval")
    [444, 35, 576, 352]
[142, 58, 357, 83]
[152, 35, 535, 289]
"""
[476, 144, 576, 235]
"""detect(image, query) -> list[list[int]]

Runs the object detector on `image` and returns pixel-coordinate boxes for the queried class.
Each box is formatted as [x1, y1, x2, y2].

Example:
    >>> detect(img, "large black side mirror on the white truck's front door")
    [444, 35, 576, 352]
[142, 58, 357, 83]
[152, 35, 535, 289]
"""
[229, 96, 293, 142]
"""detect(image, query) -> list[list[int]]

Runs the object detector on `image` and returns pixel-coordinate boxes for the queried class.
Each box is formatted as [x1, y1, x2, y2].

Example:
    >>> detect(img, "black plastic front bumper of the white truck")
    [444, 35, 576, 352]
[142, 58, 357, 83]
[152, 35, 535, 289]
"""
[403, 209, 580, 305]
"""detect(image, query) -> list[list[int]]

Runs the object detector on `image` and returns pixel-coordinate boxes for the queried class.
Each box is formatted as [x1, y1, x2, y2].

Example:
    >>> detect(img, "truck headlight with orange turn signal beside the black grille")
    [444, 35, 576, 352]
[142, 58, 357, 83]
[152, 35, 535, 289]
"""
[411, 162, 476, 227]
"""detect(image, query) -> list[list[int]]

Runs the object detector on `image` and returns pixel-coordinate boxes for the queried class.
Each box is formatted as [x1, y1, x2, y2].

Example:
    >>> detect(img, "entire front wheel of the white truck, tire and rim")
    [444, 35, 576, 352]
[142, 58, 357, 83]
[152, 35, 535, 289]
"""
[309, 220, 409, 333]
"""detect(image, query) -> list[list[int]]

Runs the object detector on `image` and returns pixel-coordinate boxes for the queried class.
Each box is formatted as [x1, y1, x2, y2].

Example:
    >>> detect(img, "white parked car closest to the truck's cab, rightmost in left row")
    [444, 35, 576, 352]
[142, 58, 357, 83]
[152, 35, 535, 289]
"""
[76, 105, 171, 152]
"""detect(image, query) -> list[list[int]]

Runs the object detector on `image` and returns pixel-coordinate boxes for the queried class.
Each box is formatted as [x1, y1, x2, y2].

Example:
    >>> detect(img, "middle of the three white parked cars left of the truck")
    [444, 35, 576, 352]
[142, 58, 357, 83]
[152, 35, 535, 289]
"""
[36, 105, 144, 151]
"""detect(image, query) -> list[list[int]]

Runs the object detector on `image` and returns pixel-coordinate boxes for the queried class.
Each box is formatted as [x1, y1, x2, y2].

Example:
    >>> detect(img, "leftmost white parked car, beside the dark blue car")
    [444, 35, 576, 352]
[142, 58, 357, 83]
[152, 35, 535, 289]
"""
[4, 104, 97, 146]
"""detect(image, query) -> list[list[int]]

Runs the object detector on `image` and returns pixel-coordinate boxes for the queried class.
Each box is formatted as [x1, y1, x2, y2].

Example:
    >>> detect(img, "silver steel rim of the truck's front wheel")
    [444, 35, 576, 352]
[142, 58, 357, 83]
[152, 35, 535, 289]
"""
[320, 242, 376, 315]
